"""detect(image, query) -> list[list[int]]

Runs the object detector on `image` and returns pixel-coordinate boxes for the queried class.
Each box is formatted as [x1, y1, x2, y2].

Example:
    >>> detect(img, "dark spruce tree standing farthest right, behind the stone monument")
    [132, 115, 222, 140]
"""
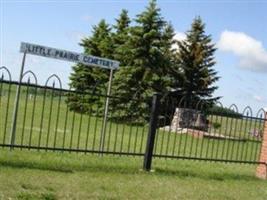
[178, 17, 219, 106]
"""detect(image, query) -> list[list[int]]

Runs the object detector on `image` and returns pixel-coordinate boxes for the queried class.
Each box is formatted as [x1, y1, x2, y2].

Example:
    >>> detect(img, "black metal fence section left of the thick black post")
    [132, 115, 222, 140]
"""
[0, 68, 148, 156]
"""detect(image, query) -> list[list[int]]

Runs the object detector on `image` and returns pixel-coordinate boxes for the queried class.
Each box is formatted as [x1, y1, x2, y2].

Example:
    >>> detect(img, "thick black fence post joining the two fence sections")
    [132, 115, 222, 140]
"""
[143, 93, 160, 171]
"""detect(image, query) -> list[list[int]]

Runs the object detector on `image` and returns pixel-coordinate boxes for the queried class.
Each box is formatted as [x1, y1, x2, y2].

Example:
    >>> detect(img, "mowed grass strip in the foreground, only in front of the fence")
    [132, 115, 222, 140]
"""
[0, 149, 267, 200]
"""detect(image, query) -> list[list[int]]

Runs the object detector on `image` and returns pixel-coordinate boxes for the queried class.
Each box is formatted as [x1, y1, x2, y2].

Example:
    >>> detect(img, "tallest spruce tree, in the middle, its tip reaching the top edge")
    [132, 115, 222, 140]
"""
[113, 0, 174, 119]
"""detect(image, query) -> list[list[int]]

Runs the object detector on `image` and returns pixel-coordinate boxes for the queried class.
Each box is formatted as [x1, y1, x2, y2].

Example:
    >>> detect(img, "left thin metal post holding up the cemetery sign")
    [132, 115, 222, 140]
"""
[10, 51, 27, 148]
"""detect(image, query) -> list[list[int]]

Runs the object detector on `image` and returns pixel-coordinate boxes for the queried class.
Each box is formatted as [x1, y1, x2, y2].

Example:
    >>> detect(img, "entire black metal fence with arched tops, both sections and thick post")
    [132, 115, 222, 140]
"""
[0, 67, 266, 169]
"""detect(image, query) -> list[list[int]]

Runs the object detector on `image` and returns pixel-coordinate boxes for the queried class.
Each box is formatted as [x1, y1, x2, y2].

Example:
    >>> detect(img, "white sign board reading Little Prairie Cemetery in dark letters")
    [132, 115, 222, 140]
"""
[20, 42, 120, 69]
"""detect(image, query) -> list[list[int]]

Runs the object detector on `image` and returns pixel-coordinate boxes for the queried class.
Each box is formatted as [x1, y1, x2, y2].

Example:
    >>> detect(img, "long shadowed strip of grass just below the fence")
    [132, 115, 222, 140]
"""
[0, 152, 259, 181]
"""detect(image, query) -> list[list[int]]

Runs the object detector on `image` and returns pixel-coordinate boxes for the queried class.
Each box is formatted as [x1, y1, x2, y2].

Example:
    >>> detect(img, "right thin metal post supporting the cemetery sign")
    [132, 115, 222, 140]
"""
[100, 69, 113, 152]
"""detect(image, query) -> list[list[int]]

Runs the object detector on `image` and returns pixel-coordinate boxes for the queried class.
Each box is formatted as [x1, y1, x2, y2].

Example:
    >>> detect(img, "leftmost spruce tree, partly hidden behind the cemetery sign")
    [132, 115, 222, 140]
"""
[67, 20, 113, 112]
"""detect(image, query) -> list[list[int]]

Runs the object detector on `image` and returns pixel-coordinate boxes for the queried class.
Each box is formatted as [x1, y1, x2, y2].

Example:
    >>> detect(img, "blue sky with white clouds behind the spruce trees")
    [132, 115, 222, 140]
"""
[0, 0, 267, 110]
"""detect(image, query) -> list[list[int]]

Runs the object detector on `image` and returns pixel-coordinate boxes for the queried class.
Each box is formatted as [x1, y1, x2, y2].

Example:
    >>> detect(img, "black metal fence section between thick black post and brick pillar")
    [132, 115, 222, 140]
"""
[153, 93, 266, 164]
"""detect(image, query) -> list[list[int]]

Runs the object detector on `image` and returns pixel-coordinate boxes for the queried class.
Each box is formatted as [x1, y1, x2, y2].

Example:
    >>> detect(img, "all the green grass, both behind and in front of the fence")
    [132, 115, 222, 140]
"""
[0, 81, 267, 200]
